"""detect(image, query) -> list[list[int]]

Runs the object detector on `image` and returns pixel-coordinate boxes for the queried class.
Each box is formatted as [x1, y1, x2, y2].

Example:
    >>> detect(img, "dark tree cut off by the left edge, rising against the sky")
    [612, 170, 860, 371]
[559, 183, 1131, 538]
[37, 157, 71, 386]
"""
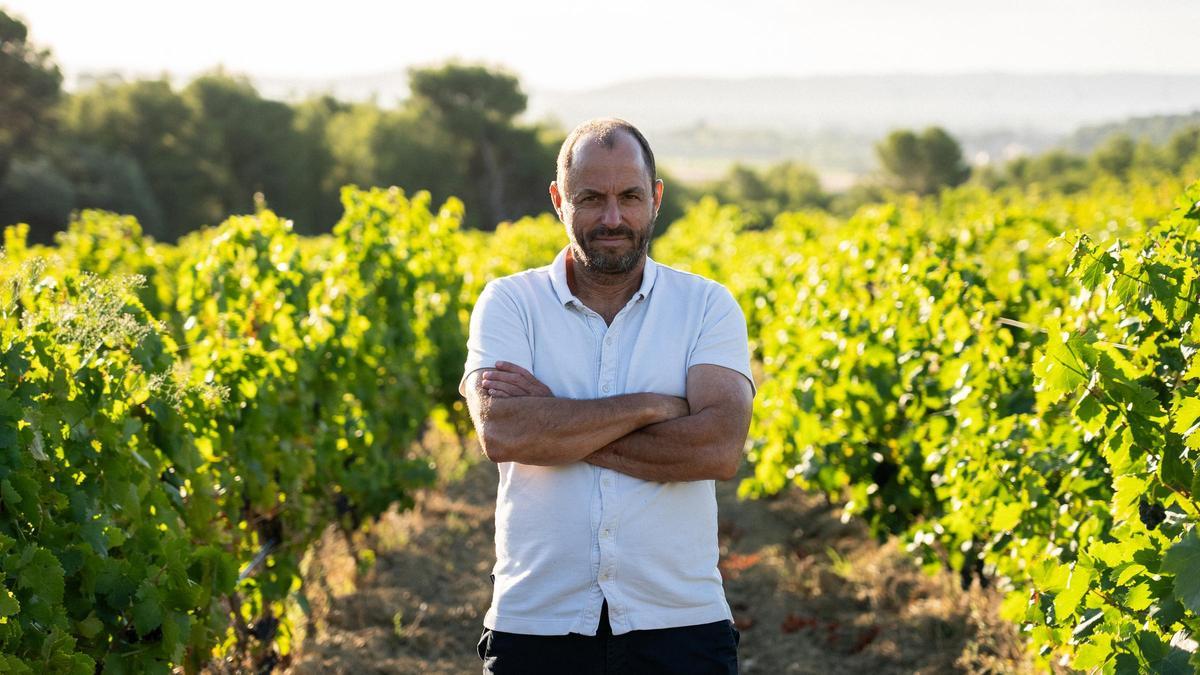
[0, 10, 62, 183]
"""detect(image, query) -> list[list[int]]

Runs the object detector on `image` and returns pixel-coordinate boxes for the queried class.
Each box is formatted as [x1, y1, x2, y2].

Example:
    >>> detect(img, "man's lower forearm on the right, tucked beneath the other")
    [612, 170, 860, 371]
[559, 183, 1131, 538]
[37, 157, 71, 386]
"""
[584, 407, 750, 483]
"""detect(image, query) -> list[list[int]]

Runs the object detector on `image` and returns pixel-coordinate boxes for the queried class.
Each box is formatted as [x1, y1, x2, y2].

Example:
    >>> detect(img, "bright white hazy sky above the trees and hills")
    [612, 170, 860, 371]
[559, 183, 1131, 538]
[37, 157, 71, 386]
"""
[9, 0, 1200, 89]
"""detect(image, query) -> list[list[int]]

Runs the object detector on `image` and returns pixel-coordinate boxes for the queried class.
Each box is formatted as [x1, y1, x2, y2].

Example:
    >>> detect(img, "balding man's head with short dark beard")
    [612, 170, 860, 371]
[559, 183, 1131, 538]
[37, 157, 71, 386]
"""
[550, 119, 662, 274]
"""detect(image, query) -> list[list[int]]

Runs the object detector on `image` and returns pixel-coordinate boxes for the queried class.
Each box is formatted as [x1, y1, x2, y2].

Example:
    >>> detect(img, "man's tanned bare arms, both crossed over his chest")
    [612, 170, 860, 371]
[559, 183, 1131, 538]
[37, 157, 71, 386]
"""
[466, 362, 754, 483]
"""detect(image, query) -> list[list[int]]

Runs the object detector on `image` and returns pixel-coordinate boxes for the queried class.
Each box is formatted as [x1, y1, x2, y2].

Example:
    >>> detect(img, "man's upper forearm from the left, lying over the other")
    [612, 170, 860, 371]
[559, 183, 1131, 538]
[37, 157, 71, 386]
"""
[476, 394, 688, 466]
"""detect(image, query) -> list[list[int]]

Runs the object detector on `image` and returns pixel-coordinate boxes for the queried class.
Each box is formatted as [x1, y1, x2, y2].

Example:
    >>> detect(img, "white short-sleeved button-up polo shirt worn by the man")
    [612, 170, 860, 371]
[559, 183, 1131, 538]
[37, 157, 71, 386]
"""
[460, 243, 754, 635]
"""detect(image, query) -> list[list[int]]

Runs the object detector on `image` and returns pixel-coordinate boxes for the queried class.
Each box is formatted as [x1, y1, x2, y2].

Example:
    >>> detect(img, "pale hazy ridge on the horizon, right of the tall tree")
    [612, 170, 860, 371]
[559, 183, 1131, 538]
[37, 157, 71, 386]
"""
[530, 73, 1200, 136]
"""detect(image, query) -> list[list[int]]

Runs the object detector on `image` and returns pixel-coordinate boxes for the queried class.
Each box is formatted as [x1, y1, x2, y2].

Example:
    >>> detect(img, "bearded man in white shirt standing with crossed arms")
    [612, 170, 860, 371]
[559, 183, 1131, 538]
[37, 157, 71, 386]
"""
[460, 119, 754, 675]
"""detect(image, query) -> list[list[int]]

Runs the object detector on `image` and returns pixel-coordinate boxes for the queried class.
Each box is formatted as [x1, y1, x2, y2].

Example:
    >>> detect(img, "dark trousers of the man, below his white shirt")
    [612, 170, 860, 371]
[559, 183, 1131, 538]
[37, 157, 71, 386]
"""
[476, 603, 740, 675]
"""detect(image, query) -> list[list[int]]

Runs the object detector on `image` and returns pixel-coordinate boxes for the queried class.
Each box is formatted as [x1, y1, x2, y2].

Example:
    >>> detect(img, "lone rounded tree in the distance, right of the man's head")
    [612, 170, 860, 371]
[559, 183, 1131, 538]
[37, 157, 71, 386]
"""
[875, 126, 971, 195]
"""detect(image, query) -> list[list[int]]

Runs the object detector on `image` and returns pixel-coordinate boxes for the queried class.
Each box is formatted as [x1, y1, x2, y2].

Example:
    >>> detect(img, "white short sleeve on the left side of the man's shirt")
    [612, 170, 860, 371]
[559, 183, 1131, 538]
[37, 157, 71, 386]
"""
[458, 281, 533, 396]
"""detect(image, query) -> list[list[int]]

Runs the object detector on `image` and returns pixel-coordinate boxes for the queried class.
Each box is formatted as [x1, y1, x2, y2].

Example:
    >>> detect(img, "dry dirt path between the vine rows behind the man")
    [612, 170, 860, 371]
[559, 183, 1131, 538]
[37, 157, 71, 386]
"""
[283, 444, 1028, 675]
